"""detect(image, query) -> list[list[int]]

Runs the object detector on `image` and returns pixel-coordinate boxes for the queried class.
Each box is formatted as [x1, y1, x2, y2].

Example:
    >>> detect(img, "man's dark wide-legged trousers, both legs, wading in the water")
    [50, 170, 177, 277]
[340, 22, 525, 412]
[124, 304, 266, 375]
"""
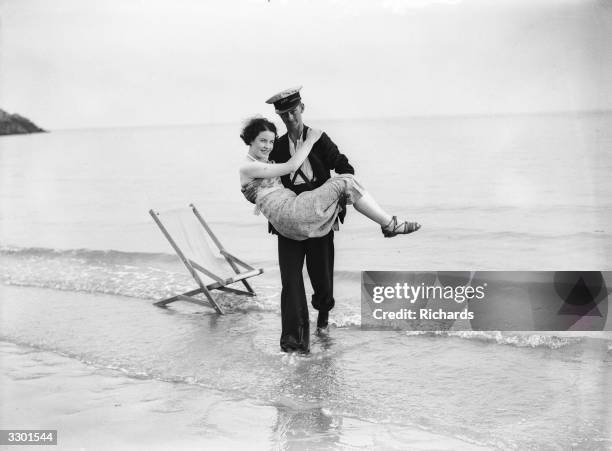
[278, 231, 335, 352]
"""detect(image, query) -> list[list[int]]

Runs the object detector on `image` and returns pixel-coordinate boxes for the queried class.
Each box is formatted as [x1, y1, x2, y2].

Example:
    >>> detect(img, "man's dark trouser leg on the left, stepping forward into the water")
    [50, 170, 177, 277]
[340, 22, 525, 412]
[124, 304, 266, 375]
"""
[278, 235, 310, 352]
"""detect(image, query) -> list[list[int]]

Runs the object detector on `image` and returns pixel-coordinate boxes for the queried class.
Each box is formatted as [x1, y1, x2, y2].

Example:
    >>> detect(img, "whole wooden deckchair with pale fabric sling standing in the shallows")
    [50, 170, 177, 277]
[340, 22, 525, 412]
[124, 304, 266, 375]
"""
[149, 204, 263, 315]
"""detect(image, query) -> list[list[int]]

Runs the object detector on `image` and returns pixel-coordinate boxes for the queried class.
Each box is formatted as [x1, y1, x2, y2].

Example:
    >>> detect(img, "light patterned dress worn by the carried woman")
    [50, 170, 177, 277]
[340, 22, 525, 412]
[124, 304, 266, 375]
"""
[242, 174, 365, 241]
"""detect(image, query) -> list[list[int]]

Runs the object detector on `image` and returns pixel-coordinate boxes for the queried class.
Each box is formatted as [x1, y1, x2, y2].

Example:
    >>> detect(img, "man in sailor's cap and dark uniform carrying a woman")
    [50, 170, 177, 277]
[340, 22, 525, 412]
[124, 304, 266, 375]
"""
[266, 86, 355, 353]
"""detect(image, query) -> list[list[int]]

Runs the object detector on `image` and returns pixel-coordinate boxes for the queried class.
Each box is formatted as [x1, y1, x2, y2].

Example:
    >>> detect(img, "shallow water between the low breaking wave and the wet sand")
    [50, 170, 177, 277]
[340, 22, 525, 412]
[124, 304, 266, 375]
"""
[0, 286, 612, 449]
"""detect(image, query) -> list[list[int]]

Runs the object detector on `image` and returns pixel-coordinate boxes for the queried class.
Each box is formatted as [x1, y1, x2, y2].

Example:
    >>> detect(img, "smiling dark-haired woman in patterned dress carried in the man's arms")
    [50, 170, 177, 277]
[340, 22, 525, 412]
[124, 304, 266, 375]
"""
[240, 118, 421, 241]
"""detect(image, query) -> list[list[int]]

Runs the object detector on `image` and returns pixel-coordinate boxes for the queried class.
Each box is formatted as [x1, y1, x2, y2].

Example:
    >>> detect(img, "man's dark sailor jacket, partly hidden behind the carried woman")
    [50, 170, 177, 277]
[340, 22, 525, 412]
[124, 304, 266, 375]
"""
[268, 125, 355, 235]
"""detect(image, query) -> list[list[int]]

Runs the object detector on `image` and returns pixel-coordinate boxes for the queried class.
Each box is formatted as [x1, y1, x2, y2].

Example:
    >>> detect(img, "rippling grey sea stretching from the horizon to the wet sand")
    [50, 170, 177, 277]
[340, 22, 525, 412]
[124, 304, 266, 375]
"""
[0, 112, 612, 450]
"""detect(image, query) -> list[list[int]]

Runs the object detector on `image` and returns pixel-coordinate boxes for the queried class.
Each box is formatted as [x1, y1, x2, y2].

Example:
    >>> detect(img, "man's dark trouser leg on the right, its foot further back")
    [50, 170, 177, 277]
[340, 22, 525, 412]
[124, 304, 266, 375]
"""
[304, 231, 335, 327]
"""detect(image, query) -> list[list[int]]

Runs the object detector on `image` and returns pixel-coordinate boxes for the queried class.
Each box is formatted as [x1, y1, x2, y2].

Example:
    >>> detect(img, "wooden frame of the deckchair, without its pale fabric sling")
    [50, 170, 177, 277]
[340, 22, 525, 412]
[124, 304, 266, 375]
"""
[149, 204, 263, 315]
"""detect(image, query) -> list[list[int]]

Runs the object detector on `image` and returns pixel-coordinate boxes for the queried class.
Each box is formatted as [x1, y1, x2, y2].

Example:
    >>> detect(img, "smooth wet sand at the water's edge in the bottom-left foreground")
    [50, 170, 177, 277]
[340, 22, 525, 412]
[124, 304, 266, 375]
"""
[0, 341, 487, 450]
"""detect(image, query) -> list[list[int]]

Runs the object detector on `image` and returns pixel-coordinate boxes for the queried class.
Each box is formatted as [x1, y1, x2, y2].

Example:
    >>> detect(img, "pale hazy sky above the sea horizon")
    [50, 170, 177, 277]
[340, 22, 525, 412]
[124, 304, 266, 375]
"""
[0, 0, 612, 130]
